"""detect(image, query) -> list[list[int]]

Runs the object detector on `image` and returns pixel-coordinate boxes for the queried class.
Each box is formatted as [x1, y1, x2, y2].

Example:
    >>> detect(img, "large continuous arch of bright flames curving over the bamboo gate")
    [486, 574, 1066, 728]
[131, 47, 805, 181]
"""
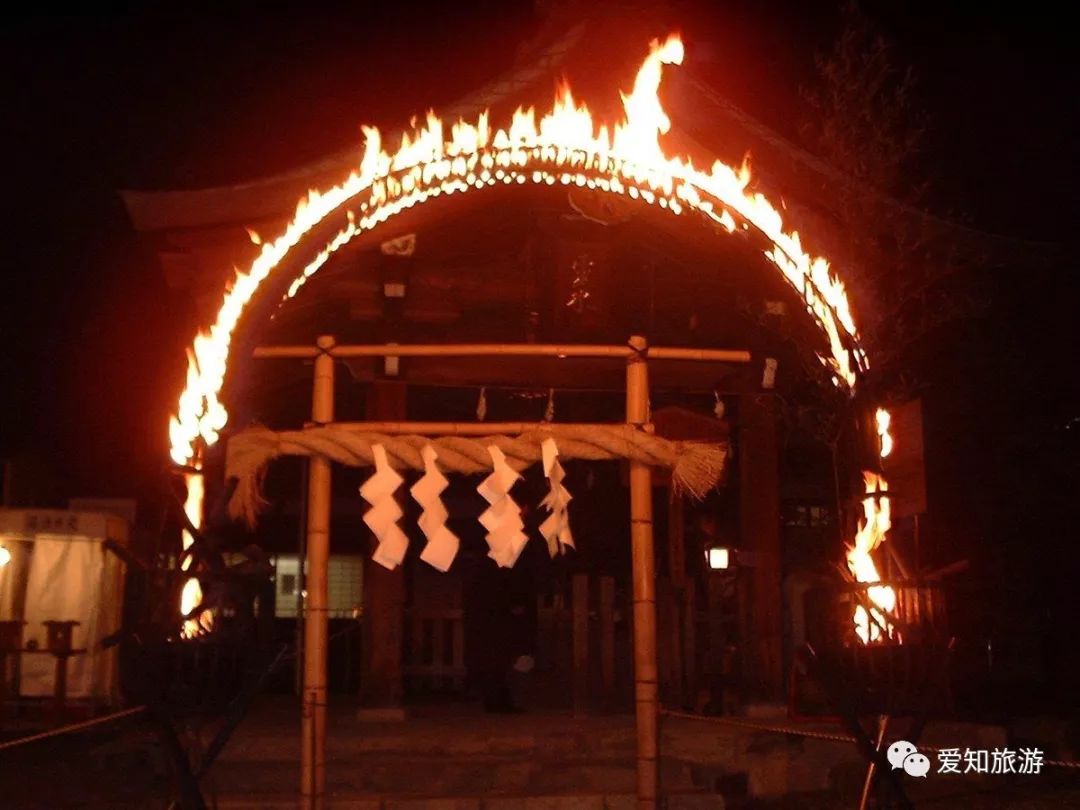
[170, 36, 868, 473]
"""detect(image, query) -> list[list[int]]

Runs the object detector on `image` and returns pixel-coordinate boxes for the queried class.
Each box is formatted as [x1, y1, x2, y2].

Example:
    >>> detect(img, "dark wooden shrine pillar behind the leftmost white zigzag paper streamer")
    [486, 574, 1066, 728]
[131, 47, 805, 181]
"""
[360, 380, 408, 719]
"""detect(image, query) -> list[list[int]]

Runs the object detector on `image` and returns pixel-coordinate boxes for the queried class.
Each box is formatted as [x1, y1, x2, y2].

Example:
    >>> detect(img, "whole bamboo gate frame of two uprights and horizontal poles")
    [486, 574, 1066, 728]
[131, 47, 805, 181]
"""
[227, 336, 751, 810]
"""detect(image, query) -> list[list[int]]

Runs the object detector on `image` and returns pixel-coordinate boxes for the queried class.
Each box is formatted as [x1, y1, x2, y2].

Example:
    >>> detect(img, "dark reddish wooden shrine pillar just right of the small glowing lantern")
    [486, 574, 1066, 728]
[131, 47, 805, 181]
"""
[739, 394, 784, 700]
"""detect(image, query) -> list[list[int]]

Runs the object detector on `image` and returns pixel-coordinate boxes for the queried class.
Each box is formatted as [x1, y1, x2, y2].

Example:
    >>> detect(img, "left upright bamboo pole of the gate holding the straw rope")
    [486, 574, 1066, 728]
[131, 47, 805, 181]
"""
[300, 335, 334, 810]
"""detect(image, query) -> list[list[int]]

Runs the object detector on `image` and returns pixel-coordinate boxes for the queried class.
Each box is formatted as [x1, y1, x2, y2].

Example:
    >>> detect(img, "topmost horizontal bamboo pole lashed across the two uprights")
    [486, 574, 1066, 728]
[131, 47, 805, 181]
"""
[253, 343, 751, 363]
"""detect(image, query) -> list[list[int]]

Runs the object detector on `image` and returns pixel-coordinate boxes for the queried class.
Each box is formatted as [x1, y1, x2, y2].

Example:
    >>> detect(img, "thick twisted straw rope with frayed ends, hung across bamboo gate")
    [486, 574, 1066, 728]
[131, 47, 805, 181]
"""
[226, 423, 728, 525]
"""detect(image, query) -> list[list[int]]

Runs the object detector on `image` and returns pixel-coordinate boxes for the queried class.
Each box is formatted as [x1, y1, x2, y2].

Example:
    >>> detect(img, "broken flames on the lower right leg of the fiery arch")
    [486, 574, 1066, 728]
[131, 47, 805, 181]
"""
[848, 408, 896, 644]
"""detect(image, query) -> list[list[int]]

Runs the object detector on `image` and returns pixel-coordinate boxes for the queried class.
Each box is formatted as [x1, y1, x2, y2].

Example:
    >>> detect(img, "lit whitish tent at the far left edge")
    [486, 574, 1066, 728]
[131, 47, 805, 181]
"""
[0, 509, 127, 705]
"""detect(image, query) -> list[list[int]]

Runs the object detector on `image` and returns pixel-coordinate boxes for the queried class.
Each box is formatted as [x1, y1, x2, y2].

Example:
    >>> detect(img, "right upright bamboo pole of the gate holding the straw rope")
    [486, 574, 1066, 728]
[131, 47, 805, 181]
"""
[626, 335, 659, 810]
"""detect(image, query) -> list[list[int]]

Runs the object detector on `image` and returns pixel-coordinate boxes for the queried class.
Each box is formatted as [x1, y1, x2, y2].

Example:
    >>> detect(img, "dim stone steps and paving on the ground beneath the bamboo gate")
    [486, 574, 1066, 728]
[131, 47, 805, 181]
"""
[206, 699, 860, 810]
